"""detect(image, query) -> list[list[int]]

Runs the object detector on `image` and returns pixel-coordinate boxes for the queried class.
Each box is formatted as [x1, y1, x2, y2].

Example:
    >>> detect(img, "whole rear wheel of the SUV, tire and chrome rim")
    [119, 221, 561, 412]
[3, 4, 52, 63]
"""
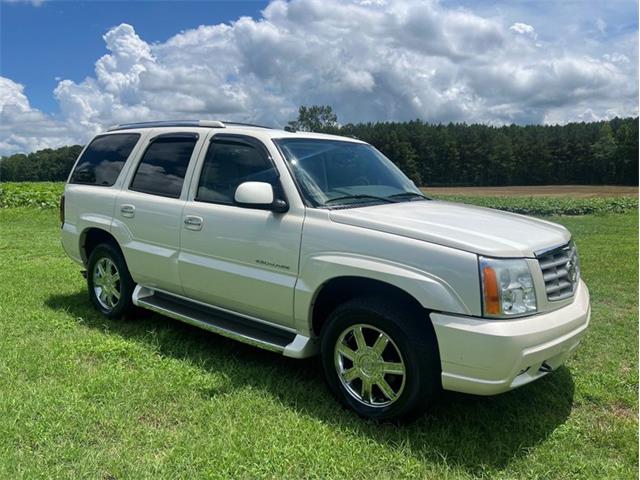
[87, 243, 135, 318]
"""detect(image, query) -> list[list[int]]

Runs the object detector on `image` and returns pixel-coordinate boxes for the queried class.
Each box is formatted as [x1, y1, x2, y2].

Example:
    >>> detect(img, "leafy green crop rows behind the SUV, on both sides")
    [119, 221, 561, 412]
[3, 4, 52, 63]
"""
[0, 182, 638, 216]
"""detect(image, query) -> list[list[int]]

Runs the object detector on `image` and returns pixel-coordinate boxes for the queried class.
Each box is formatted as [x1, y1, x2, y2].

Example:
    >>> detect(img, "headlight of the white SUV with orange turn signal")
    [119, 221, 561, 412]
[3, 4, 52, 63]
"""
[480, 257, 538, 318]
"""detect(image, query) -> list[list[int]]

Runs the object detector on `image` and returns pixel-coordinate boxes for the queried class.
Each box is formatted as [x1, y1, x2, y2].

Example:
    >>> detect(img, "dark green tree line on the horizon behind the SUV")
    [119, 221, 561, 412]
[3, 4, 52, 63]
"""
[0, 110, 638, 186]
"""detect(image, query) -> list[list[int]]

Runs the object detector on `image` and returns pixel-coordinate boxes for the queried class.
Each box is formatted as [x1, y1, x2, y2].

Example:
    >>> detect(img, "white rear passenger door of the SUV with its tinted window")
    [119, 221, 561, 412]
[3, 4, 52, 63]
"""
[112, 131, 202, 294]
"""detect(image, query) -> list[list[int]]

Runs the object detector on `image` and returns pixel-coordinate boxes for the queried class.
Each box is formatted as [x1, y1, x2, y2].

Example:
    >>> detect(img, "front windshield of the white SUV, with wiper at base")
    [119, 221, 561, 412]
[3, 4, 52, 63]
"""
[274, 138, 425, 208]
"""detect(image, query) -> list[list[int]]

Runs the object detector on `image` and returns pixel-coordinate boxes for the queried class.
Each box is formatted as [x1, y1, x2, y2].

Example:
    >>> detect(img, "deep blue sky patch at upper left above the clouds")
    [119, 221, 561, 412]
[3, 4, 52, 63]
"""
[0, 0, 268, 112]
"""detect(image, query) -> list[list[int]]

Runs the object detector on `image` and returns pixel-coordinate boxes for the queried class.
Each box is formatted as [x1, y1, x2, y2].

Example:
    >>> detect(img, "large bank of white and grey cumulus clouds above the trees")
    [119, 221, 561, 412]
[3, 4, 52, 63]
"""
[0, 0, 638, 153]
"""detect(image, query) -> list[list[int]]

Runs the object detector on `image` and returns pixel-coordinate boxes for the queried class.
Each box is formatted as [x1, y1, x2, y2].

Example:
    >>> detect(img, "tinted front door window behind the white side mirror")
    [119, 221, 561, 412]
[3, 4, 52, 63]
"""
[196, 140, 278, 203]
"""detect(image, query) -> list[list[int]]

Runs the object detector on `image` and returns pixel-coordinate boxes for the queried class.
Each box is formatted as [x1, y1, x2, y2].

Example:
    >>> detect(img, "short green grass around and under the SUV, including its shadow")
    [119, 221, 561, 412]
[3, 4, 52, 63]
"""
[0, 184, 638, 479]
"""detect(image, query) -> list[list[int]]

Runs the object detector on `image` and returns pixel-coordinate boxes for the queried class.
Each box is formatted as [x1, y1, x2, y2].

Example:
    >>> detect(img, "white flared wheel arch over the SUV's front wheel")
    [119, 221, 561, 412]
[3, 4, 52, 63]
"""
[294, 252, 473, 334]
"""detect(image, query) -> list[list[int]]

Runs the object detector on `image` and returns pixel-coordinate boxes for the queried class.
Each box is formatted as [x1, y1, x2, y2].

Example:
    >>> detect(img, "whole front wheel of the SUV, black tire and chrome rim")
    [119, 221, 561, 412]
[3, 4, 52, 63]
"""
[321, 297, 441, 420]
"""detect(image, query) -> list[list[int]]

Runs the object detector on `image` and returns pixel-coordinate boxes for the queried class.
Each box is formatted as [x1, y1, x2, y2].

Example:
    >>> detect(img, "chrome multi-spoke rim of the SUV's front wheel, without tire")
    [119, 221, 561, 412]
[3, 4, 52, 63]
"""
[334, 324, 406, 407]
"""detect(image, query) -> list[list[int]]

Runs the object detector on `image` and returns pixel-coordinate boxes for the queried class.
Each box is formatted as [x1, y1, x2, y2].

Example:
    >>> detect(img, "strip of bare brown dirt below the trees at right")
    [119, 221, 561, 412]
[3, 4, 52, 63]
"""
[422, 185, 638, 198]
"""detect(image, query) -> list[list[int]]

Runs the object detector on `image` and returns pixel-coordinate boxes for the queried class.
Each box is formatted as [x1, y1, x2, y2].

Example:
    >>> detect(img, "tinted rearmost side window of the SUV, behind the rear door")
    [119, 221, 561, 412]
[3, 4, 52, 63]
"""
[69, 133, 140, 187]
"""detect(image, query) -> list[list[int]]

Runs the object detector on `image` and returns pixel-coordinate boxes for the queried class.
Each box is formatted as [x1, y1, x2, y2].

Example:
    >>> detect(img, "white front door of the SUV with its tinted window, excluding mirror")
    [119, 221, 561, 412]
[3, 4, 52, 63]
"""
[179, 134, 304, 326]
